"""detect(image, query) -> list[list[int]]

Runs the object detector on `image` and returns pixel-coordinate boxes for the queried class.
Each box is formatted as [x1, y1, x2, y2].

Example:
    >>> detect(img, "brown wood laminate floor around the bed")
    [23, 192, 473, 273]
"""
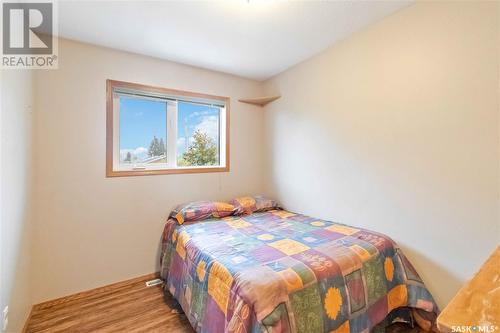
[25, 275, 423, 333]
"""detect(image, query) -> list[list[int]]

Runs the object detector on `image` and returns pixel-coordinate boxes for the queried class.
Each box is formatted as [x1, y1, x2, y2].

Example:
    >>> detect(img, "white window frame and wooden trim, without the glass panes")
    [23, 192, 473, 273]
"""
[106, 80, 229, 177]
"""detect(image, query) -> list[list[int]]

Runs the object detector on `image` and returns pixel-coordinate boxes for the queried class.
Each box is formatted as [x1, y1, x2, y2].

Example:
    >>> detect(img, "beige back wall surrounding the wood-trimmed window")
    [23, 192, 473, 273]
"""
[33, 40, 264, 302]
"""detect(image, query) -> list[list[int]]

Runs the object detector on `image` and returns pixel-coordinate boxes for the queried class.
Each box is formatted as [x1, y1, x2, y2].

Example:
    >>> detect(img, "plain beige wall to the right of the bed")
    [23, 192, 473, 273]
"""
[265, 2, 500, 306]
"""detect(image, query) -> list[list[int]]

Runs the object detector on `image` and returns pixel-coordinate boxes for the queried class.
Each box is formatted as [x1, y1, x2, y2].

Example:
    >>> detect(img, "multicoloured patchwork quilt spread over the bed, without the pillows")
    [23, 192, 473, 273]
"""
[161, 210, 438, 333]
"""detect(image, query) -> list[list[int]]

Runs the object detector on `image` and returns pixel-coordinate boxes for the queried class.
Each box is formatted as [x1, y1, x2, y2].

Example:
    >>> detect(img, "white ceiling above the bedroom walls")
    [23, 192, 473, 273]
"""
[59, 0, 413, 80]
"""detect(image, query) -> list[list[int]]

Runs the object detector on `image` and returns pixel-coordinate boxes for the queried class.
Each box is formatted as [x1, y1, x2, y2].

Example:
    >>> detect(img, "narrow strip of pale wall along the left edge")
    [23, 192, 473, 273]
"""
[0, 70, 33, 332]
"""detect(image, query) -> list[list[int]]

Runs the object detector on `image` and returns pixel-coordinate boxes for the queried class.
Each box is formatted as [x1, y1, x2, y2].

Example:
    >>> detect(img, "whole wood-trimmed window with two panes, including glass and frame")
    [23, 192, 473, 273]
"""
[106, 80, 229, 177]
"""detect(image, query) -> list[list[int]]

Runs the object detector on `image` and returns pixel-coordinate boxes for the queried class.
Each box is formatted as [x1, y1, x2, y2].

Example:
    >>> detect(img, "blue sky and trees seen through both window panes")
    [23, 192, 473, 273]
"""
[119, 96, 220, 167]
